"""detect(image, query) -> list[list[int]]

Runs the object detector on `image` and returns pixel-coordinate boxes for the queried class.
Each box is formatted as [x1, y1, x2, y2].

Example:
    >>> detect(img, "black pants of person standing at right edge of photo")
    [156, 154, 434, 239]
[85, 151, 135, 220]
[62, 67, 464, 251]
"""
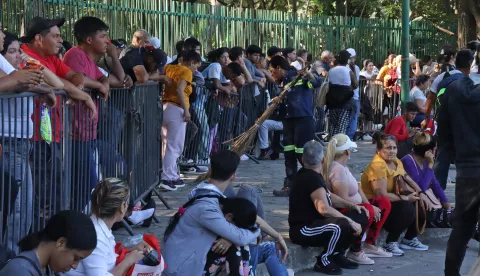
[445, 177, 480, 276]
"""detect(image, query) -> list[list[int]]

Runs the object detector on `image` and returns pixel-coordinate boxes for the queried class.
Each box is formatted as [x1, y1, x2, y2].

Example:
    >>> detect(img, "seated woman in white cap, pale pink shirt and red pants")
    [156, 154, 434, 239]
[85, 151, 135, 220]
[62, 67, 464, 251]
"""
[323, 134, 392, 264]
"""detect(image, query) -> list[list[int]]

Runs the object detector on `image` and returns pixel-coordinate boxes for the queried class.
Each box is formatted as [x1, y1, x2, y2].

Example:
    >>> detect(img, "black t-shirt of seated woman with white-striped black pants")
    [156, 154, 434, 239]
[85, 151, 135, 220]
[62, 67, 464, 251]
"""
[288, 168, 332, 227]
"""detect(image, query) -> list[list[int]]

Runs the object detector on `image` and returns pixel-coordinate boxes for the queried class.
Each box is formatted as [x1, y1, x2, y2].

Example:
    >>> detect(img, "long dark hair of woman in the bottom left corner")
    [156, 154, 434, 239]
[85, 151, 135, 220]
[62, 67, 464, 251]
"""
[18, 210, 97, 252]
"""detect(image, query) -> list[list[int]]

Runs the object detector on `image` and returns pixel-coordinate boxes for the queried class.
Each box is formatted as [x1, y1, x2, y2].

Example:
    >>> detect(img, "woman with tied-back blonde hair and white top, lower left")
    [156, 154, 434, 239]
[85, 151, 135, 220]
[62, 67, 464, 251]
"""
[66, 178, 146, 276]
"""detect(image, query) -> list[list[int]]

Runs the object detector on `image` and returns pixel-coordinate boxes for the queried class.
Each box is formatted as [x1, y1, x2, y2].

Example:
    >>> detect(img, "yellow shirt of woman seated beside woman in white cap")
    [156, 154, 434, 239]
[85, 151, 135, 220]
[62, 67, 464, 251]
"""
[360, 154, 407, 199]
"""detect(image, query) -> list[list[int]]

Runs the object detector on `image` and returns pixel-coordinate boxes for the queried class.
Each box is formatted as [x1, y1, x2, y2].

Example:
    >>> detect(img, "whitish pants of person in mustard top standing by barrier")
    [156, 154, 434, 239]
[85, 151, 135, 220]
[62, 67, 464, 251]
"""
[162, 103, 187, 181]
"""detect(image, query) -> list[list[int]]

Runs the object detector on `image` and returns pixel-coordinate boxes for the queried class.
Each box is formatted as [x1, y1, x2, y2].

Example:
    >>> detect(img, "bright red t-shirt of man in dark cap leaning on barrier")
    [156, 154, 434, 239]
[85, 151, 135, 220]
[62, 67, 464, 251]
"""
[22, 44, 71, 143]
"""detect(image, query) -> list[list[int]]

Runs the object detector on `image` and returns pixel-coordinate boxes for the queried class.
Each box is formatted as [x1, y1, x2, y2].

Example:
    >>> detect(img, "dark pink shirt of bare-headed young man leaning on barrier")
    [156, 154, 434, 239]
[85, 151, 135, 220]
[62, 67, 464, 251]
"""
[63, 46, 104, 141]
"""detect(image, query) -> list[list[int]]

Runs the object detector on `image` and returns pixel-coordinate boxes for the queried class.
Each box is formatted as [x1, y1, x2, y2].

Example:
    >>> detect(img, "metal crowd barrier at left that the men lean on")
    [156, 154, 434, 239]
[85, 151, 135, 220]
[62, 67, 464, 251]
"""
[0, 84, 170, 250]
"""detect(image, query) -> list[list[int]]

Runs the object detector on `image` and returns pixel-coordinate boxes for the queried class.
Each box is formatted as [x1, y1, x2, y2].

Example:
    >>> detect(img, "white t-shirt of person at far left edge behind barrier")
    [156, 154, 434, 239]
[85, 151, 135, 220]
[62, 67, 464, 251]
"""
[0, 55, 34, 139]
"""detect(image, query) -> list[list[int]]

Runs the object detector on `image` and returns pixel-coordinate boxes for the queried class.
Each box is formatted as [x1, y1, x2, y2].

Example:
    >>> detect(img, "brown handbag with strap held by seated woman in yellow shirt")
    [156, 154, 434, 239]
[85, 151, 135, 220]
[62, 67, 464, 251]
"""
[394, 174, 427, 234]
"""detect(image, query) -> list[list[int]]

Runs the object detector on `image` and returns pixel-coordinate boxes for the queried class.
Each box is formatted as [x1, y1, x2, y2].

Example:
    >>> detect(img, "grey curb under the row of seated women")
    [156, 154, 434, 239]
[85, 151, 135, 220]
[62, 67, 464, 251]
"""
[255, 228, 452, 276]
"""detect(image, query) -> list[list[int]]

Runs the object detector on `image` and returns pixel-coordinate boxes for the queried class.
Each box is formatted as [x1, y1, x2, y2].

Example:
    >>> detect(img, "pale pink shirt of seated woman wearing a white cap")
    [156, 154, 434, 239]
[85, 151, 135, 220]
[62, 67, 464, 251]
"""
[327, 161, 362, 204]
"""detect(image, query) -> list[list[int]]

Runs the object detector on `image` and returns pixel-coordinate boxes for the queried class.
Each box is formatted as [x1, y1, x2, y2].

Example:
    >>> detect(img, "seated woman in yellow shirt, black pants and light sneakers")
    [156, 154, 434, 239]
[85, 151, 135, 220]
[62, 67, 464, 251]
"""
[361, 134, 428, 256]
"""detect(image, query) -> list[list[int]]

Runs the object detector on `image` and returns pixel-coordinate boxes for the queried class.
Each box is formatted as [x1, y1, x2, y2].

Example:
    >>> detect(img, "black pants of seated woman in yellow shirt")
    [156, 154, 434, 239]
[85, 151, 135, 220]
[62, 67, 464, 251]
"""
[383, 200, 417, 243]
